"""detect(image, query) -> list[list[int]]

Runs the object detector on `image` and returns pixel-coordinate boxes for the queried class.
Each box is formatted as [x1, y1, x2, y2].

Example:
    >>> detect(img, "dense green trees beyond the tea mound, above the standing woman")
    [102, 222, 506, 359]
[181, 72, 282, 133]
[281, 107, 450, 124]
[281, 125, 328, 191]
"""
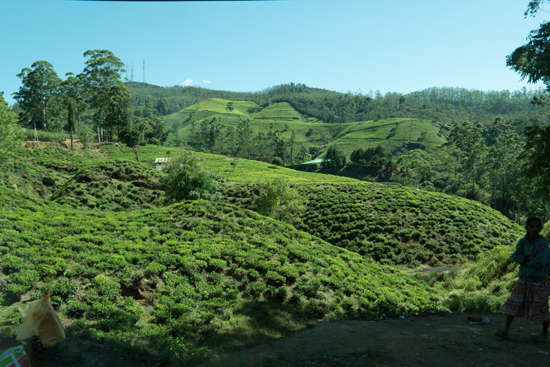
[436, 118, 548, 218]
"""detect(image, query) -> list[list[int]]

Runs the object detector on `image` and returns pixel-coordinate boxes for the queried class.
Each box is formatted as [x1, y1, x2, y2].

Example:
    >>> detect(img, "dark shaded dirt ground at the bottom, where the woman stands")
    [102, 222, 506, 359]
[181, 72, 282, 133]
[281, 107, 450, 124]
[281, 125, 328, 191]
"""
[4, 314, 550, 367]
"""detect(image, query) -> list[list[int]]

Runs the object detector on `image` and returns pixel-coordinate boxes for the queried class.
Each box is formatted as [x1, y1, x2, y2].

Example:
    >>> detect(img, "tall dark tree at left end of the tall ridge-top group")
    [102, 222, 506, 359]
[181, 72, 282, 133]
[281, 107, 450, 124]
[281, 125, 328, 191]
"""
[14, 60, 61, 129]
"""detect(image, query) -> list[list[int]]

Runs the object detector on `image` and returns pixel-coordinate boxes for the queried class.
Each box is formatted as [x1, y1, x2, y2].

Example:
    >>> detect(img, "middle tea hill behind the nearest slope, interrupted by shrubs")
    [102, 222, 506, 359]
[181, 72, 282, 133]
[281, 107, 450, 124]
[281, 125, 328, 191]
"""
[4, 145, 522, 266]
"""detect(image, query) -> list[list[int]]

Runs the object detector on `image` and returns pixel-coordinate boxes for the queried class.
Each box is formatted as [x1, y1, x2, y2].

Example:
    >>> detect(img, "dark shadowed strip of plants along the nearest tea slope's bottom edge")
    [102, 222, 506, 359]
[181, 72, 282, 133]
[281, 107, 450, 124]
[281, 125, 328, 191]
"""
[0, 301, 317, 367]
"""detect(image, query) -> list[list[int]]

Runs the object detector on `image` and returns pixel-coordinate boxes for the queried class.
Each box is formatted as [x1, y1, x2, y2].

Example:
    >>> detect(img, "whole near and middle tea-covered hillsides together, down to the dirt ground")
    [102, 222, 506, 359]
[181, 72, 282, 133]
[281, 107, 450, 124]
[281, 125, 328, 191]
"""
[0, 140, 532, 364]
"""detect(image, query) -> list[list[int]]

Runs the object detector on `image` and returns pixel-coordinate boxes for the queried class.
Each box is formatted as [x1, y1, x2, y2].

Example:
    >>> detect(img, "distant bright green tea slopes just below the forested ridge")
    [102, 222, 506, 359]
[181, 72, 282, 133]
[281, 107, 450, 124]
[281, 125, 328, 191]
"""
[165, 98, 450, 162]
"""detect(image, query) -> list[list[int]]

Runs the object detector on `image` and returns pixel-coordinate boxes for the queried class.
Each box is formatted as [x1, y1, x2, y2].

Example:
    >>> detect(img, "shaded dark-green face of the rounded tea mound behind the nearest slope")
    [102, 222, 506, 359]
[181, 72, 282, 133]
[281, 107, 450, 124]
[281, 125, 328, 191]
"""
[222, 182, 523, 266]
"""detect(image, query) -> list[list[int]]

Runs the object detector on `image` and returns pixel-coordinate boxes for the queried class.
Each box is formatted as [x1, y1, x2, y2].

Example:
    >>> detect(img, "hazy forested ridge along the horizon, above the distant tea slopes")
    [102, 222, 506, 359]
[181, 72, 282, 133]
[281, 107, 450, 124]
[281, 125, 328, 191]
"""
[126, 82, 548, 130]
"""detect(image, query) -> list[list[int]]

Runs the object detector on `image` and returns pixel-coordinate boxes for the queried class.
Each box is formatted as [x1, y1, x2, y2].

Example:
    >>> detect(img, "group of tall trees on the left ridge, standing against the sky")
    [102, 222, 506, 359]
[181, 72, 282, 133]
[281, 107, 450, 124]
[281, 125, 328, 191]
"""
[9, 50, 169, 151]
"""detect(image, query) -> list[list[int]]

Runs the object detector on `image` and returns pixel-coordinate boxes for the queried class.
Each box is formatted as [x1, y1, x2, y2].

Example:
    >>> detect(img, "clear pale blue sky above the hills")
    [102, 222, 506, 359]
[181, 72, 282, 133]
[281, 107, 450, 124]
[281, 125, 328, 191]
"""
[0, 0, 547, 104]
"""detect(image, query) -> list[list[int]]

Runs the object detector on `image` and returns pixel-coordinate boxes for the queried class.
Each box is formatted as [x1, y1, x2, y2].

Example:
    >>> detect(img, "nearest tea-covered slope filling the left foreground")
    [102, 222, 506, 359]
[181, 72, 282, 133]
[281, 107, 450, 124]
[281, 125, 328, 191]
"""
[0, 188, 441, 362]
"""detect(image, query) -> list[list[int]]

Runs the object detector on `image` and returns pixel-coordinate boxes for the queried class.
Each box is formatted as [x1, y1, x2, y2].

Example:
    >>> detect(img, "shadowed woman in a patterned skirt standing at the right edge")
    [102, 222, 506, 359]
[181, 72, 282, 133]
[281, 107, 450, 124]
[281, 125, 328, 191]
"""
[495, 217, 550, 342]
